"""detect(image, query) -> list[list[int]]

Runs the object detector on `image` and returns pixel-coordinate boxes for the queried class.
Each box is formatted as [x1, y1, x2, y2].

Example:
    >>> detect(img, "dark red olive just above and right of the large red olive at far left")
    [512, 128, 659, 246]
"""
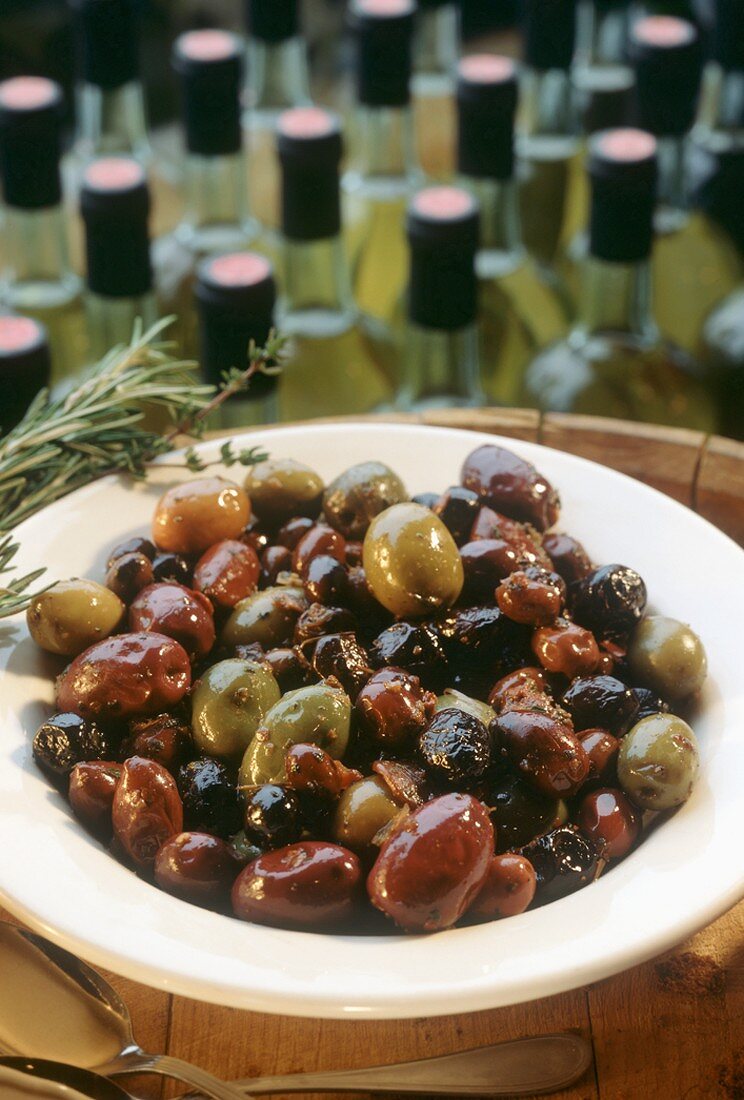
[129, 583, 217, 660]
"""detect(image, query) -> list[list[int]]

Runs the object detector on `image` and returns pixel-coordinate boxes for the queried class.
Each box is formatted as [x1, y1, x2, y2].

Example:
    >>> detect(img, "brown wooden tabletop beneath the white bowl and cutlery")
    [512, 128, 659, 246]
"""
[5, 409, 744, 1100]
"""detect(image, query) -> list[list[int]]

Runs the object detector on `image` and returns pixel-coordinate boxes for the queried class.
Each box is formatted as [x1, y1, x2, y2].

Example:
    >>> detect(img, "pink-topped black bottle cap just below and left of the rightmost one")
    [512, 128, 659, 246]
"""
[588, 129, 657, 263]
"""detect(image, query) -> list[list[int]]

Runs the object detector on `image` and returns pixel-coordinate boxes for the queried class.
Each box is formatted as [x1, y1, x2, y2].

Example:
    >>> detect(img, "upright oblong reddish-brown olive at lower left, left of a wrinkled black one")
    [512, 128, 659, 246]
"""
[111, 757, 184, 870]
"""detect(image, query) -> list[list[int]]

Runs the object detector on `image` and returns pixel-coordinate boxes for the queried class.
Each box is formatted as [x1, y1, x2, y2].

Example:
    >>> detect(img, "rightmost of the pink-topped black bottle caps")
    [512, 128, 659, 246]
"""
[630, 15, 702, 136]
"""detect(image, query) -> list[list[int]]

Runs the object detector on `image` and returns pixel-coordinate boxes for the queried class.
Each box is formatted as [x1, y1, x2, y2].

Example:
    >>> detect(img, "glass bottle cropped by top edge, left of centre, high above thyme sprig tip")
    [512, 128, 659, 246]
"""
[243, 0, 311, 230]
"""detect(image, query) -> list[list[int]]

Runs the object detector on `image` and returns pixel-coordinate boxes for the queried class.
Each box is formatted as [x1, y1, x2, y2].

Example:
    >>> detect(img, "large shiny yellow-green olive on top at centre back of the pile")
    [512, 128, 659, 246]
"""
[362, 502, 463, 618]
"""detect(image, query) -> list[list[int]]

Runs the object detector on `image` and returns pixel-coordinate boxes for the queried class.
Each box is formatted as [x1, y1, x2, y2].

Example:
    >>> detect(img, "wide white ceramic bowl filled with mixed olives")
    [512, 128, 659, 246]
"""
[0, 425, 744, 1018]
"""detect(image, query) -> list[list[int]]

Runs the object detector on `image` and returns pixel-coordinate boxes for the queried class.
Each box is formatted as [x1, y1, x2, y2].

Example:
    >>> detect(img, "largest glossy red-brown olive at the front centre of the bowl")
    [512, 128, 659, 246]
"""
[366, 792, 494, 932]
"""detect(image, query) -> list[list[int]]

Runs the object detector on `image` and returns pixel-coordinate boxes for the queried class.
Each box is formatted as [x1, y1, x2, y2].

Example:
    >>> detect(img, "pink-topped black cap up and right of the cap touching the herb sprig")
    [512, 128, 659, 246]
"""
[276, 107, 343, 241]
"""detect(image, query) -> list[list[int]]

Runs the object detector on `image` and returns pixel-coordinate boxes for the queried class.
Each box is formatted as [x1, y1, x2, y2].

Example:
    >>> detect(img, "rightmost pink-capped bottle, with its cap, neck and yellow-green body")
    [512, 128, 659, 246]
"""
[631, 15, 742, 351]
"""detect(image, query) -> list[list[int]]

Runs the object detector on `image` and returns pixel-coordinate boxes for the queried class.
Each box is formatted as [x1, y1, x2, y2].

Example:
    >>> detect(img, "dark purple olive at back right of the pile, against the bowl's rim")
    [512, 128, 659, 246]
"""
[460, 443, 560, 531]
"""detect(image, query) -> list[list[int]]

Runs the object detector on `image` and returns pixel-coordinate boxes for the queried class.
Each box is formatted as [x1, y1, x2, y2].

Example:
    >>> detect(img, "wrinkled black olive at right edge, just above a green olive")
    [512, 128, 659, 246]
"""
[571, 564, 646, 641]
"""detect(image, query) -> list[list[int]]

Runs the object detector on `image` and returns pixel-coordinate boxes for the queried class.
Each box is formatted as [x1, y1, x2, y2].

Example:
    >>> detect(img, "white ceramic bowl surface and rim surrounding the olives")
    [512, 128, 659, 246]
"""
[0, 425, 744, 1018]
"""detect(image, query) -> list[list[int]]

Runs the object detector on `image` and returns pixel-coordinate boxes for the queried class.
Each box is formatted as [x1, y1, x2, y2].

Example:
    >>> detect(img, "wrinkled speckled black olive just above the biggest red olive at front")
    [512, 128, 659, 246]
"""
[418, 706, 491, 791]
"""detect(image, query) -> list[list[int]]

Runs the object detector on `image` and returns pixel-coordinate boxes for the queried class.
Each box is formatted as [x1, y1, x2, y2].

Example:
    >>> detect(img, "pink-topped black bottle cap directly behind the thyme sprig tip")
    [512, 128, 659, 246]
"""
[196, 252, 277, 400]
